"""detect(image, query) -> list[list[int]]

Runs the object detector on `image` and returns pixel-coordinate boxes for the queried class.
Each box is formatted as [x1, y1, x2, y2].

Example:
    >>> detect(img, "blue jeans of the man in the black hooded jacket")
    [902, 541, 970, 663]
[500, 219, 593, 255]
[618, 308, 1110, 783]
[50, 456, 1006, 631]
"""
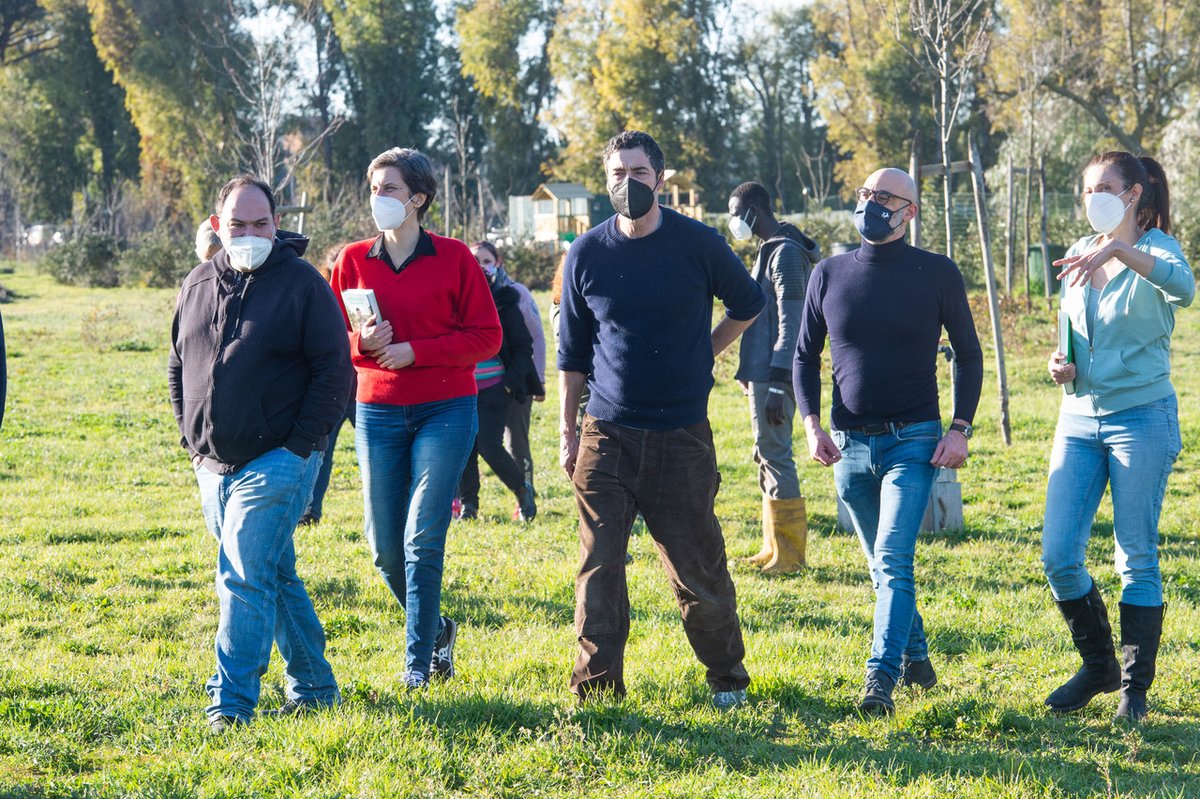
[196, 447, 340, 721]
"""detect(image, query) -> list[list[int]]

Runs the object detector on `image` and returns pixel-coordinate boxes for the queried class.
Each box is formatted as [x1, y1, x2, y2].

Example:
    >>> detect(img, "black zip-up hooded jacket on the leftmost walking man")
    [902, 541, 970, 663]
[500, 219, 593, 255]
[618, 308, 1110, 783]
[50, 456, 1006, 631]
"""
[167, 232, 352, 474]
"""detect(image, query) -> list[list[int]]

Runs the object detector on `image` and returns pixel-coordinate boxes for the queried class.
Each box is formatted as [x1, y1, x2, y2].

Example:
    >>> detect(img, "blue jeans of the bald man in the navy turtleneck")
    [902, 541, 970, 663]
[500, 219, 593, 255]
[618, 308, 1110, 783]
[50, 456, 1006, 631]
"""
[833, 421, 942, 679]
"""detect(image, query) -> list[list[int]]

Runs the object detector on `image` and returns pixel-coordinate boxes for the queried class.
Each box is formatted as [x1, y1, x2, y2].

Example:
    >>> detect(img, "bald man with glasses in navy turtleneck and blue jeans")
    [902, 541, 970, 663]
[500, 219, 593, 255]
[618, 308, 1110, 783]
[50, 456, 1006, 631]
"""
[796, 169, 983, 714]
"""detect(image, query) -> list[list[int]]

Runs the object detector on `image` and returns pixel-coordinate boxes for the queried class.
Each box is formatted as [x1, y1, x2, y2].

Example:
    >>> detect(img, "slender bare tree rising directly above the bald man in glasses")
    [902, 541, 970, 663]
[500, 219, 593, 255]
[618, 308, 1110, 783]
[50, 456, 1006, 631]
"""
[893, 0, 992, 258]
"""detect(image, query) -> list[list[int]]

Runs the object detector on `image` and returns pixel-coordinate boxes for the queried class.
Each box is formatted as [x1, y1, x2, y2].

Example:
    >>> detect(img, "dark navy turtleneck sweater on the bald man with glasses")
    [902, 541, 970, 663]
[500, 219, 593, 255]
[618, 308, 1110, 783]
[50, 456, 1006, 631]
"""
[793, 239, 983, 429]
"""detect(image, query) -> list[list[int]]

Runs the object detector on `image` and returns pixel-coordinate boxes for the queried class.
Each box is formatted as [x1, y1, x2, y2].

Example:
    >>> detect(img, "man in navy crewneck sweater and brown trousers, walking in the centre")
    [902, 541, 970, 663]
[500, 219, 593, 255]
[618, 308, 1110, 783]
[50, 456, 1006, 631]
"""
[558, 131, 764, 709]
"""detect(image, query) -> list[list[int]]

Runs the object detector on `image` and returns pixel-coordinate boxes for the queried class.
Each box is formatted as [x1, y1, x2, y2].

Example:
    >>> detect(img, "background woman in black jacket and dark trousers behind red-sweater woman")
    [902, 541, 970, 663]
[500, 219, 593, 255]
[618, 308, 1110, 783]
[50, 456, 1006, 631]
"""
[458, 241, 546, 522]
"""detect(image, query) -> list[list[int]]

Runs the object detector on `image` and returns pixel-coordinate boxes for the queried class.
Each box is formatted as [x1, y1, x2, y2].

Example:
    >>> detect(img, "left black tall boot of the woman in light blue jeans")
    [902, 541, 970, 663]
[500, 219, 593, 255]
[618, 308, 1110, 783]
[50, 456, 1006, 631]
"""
[1046, 582, 1121, 713]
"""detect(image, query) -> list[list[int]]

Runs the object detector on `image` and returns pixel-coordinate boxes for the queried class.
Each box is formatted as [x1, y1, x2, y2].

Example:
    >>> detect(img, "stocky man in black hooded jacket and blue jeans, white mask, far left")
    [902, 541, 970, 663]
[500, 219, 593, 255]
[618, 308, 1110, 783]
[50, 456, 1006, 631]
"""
[168, 175, 350, 733]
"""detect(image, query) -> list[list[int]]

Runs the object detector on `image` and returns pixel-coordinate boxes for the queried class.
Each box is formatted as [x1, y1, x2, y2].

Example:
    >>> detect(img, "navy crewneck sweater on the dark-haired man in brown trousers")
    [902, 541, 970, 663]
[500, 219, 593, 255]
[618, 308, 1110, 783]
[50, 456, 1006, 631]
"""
[558, 209, 766, 429]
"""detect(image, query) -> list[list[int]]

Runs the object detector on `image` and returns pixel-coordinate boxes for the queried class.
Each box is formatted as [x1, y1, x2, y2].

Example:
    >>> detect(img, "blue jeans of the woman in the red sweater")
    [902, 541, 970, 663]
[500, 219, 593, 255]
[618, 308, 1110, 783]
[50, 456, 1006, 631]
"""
[354, 395, 479, 675]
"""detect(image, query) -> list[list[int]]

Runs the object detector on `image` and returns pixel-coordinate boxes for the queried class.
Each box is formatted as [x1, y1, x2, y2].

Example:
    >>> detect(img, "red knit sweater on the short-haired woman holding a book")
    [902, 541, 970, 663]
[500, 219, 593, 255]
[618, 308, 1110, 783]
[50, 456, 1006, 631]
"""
[331, 234, 500, 405]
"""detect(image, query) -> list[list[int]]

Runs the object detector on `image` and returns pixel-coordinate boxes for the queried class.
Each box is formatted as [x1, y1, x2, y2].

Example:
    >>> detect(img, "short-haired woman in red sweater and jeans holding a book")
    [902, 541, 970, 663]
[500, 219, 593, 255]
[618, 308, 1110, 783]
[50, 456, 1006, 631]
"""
[332, 148, 500, 689]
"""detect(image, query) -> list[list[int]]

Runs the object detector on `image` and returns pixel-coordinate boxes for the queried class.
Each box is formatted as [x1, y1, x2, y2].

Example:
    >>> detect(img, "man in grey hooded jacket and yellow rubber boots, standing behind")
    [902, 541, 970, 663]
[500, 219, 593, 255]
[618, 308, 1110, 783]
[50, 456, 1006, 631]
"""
[730, 182, 821, 573]
